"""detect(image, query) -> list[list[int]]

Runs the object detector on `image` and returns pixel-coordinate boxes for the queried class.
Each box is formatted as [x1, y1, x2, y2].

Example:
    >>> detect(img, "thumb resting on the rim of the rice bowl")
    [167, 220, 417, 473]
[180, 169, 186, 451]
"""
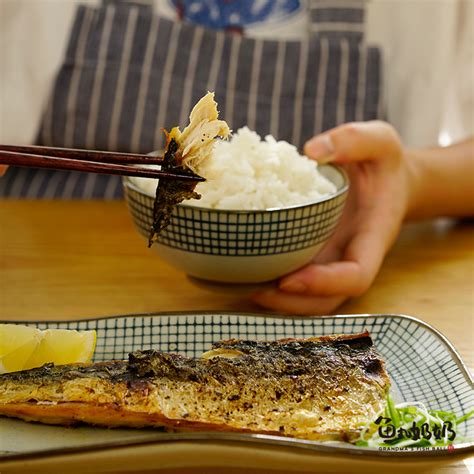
[304, 120, 402, 163]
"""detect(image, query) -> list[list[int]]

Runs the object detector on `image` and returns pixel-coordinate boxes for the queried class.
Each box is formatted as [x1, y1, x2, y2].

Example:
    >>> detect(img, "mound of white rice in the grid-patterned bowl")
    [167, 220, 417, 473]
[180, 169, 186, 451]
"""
[133, 127, 336, 210]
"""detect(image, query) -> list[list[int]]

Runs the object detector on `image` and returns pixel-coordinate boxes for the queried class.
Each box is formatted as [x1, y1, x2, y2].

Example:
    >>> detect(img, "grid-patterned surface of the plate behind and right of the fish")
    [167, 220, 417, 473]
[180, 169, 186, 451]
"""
[30, 313, 474, 438]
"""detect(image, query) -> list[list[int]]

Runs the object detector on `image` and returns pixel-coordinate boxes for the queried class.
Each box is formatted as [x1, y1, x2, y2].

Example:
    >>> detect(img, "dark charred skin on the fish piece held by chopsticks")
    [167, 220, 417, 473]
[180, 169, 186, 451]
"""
[148, 139, 201, 247]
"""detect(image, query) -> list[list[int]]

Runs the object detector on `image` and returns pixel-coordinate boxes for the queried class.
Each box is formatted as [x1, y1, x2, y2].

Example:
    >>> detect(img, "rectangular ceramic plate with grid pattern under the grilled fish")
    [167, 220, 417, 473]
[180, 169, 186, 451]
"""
[0, 313, 474, 460]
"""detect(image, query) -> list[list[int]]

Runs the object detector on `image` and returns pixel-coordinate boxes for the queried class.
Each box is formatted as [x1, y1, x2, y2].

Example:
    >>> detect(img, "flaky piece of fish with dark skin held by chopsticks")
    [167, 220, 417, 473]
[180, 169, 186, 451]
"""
[148, 92, 230, 247]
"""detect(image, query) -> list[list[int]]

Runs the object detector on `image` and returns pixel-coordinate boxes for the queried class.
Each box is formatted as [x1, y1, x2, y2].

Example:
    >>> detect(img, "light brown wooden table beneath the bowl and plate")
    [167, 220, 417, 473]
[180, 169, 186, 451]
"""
[0, 201, 474, 472]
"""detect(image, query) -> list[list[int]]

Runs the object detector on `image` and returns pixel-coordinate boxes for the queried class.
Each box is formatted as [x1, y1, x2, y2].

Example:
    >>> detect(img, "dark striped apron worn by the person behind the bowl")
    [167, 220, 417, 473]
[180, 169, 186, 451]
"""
[0, 0, 381, 199]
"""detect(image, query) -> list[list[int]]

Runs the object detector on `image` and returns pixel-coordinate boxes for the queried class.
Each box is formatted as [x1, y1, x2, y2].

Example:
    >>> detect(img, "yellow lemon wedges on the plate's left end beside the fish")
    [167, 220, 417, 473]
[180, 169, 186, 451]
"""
[0, 324, 96, 373]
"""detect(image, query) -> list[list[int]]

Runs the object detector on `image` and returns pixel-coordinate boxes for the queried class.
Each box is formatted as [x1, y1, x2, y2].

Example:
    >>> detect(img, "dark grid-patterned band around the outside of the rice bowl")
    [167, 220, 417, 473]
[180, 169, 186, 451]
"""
[124, 180, 347, 256]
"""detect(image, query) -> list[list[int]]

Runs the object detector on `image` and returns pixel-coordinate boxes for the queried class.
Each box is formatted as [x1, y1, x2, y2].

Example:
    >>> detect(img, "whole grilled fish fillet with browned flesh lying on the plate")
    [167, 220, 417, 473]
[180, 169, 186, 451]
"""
[0, 332, 390, 441]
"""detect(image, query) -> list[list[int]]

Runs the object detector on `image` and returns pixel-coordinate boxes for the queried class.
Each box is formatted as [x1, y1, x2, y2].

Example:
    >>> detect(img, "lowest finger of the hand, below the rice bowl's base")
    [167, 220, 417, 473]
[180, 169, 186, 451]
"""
[252, 289, 346, 316]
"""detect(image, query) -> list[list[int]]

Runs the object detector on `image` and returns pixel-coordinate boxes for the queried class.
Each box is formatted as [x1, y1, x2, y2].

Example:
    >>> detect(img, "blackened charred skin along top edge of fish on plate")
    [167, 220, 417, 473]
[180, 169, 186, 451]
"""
[129, 334, 388, 383]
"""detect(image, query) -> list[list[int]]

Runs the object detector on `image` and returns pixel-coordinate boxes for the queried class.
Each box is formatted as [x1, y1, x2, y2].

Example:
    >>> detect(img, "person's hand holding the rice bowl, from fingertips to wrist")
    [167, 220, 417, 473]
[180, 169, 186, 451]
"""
[253, 121, 410, 315]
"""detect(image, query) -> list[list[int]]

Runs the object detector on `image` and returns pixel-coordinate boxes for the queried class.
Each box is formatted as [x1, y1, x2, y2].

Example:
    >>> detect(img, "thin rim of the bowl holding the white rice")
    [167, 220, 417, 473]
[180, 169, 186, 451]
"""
[122, 163, 350, 214]
